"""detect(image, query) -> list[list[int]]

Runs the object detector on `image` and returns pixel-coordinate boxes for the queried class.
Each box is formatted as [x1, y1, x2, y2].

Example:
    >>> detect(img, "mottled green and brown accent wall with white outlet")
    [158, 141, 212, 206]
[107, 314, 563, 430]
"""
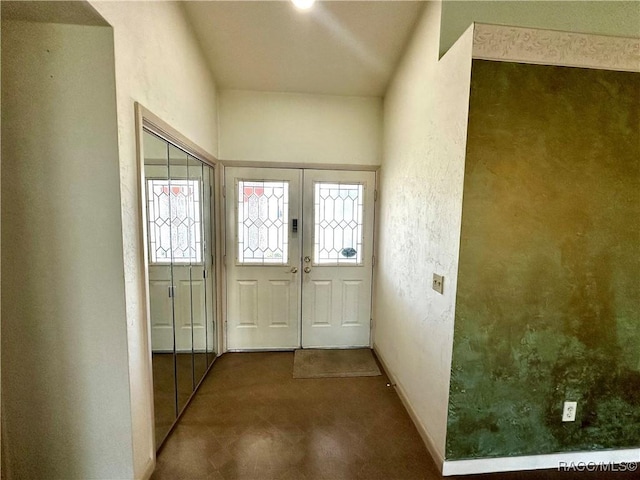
[446, 60, 640, 459]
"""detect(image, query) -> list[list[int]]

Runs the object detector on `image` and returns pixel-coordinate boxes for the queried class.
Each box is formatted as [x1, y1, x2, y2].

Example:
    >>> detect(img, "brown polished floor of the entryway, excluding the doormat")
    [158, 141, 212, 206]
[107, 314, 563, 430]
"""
[152, 352, 639, 480]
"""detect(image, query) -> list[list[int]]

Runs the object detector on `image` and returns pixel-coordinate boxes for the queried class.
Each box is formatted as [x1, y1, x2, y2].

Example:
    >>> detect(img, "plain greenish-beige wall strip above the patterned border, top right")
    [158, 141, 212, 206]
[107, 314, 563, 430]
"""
[440, 0, 640, 55]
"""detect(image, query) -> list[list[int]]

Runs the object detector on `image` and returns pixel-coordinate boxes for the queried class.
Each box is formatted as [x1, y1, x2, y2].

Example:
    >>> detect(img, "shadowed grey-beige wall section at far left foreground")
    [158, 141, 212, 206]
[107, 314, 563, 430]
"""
[2, 21, 133, 479]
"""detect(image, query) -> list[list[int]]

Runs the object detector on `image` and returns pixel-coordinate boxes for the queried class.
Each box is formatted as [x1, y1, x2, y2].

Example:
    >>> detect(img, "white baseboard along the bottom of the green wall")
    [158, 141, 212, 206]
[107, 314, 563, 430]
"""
[442, 448, 640, 476]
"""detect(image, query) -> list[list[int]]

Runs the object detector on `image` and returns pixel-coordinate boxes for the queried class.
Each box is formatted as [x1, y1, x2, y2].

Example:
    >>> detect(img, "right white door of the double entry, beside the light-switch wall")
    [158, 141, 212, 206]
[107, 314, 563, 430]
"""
[302, 170, 375, 348]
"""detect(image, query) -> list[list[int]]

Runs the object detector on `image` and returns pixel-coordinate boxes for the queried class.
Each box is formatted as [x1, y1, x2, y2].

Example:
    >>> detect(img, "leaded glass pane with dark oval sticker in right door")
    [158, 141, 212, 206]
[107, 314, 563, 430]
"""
[313, 182, 364, 265]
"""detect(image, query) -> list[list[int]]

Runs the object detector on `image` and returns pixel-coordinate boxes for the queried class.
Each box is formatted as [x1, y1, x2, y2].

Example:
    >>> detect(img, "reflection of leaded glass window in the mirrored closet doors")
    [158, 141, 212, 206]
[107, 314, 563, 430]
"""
[147, 179, 202, 263]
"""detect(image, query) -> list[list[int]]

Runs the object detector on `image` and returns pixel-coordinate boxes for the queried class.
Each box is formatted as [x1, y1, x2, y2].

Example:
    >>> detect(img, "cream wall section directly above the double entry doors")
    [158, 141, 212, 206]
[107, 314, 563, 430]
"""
[220, 90, 382, 165]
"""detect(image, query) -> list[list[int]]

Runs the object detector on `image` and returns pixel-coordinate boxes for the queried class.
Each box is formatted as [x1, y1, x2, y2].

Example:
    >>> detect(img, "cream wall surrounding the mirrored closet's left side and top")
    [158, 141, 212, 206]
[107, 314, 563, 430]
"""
[91, 2, 218, 478]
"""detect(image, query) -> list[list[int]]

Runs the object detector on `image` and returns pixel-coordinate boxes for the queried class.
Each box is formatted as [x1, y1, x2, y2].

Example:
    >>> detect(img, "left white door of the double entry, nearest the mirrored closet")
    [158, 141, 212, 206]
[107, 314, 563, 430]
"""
[225, 167, 301, 350]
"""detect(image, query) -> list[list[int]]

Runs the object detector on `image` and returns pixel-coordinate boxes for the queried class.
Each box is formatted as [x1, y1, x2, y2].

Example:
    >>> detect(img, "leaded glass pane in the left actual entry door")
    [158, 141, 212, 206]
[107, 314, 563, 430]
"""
[238, 180, 289, 265]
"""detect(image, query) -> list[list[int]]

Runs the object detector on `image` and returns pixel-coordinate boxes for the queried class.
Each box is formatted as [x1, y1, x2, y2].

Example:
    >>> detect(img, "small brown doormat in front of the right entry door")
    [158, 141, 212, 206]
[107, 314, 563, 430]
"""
[293, 348, 381, 378]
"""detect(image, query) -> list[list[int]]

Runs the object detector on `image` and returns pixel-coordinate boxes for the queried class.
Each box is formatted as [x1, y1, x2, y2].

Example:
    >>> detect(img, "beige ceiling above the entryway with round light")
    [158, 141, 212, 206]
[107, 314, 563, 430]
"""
[182, 1, 423, 96]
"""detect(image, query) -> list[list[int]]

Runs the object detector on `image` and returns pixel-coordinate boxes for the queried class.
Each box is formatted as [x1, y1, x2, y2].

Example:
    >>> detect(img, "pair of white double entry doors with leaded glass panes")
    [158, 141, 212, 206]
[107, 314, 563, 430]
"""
[225, 167, 375, 350]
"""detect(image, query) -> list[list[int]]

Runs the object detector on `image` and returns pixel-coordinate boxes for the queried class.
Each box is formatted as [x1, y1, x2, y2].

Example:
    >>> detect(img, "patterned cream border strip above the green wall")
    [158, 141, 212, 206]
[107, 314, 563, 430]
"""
[472, 23, 640, 72]
